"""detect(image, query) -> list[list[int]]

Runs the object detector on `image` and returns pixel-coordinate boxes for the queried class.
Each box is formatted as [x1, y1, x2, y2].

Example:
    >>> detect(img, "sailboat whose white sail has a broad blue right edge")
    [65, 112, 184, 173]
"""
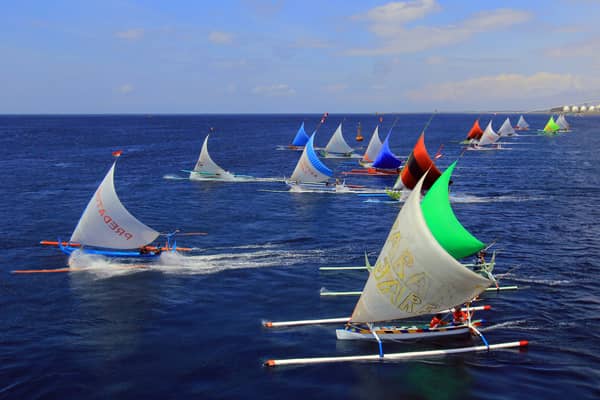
[285, 133, 347, 192]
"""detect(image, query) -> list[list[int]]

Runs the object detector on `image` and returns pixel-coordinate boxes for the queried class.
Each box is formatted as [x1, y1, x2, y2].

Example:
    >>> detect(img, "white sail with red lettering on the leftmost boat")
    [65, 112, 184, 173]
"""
[71, 161, 159, 249]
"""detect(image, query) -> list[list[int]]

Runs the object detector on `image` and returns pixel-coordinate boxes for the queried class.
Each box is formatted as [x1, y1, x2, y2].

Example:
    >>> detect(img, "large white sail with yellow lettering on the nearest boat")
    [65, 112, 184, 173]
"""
[350, 175, 491, 323]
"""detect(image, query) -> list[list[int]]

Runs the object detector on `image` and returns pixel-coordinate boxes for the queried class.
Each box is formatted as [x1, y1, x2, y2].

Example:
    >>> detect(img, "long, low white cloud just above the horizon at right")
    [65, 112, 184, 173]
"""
[406, 72, 588, 104]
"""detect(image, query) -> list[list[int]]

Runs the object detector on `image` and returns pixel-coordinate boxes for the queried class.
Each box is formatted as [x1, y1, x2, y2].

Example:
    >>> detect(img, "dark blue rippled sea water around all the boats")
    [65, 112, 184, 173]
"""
[0, 114, 600, 400]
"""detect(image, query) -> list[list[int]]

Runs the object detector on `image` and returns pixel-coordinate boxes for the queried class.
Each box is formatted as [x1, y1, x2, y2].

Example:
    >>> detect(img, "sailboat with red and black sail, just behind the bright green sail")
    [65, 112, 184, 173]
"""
[386, 132, 442, 200]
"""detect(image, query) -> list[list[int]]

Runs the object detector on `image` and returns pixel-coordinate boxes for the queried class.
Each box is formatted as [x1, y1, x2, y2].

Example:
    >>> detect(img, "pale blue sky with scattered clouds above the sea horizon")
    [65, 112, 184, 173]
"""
[0, 0, 600, 114]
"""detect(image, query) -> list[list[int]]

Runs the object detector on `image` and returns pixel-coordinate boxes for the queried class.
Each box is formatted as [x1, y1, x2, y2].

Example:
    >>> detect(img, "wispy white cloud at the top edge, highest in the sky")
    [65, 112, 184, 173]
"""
[346, 6, 531, 56]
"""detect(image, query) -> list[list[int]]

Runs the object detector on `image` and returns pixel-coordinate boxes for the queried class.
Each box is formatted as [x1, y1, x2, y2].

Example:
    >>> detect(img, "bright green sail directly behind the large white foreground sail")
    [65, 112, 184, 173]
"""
[421, 161, 485, 259]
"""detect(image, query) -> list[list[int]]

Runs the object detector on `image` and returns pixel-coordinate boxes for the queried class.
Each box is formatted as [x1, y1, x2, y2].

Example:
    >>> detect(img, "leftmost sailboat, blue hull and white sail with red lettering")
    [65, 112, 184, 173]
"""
[41, 152, 179, 258]
